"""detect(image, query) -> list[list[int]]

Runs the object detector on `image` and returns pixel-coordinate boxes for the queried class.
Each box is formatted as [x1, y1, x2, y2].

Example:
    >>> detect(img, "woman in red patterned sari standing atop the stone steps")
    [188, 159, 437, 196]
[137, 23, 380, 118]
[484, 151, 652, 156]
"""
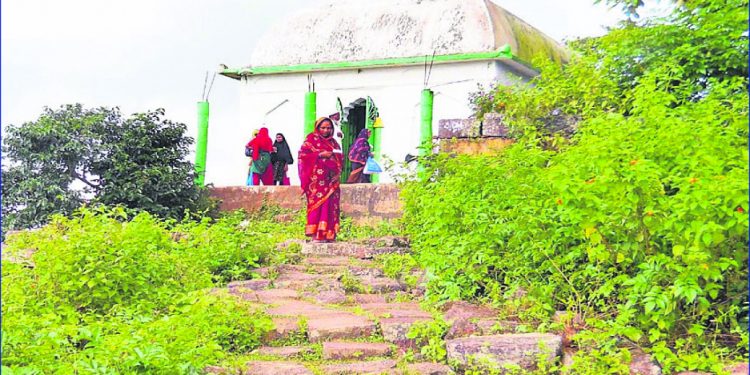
[297, 117, 343, 242]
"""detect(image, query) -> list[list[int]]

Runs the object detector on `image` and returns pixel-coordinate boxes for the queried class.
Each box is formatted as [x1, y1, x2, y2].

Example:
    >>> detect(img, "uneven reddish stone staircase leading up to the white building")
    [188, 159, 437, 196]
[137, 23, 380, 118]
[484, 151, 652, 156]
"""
[205, 238, 562, 375]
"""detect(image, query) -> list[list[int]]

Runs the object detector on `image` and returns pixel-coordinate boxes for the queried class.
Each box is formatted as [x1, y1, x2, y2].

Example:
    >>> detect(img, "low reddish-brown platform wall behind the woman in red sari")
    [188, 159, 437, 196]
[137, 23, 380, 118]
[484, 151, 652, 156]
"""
[211, 184, 402, 219]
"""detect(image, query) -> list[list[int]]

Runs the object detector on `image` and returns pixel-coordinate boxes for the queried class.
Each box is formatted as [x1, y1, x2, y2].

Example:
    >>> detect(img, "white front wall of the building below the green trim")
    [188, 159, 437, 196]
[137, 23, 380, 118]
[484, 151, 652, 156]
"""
[208, 61, 524, 185]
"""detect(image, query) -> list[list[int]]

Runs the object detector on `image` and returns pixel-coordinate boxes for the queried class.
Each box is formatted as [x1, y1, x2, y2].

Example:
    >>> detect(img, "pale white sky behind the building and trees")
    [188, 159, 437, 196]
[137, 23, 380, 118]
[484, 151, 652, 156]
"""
[0, 0, 668, 183]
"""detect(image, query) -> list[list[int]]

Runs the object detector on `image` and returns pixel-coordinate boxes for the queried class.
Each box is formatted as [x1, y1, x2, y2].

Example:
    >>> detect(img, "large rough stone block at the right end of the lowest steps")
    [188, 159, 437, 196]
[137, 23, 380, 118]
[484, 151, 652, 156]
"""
[445, 333, 562, 371]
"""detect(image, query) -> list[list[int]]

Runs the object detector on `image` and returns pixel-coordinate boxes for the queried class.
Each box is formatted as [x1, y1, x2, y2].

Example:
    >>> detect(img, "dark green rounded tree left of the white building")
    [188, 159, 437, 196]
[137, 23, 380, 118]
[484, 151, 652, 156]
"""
[2, 104, 211, 233]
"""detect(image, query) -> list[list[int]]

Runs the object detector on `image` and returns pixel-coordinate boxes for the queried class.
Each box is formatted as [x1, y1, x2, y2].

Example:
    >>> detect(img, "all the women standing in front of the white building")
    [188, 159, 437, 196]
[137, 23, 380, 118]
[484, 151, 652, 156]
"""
[247, 117, 372, 242]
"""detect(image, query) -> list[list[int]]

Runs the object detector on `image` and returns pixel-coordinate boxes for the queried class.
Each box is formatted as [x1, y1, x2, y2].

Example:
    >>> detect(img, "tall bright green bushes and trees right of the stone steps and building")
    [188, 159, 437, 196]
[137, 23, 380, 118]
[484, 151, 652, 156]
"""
[403, 0, 748, 373]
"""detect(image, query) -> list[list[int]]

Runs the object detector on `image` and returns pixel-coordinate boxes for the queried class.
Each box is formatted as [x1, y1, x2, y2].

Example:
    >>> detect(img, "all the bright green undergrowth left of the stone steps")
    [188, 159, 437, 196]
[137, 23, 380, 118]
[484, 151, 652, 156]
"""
[2, 208, 280, 374]
